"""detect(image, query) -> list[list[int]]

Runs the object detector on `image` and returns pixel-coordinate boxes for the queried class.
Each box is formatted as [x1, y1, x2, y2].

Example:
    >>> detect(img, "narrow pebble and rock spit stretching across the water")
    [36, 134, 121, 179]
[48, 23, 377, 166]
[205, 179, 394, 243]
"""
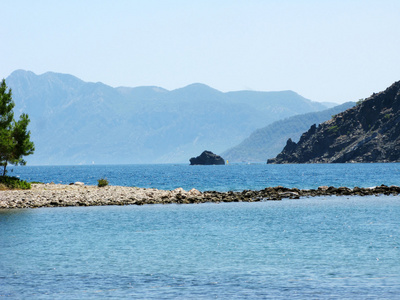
[0, 183, 400, 209]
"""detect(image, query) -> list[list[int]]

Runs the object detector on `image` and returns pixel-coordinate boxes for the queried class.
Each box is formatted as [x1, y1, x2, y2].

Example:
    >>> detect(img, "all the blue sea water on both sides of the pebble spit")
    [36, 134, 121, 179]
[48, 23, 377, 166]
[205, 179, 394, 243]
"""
[0, 163, 400, 299]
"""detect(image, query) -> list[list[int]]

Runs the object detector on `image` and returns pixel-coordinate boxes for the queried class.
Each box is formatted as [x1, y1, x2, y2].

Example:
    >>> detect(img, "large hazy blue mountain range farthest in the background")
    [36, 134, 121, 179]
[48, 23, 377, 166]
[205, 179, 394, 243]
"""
[6, 70, 326, 165]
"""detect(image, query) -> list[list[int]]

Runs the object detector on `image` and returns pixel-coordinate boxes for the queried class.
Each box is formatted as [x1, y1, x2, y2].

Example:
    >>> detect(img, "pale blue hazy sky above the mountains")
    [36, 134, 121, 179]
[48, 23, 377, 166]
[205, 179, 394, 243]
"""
[0, 0, 400, 103]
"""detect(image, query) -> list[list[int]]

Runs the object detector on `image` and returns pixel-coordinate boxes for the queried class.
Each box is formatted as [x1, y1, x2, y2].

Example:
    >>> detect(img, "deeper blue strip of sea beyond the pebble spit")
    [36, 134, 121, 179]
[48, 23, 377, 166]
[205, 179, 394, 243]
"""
[8, 163, 400, 191]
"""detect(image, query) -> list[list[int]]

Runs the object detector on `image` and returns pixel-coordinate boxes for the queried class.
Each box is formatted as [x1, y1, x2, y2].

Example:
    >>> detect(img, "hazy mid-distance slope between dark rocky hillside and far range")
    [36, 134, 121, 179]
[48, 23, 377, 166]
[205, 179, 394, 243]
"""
[221, 102, 356, 162]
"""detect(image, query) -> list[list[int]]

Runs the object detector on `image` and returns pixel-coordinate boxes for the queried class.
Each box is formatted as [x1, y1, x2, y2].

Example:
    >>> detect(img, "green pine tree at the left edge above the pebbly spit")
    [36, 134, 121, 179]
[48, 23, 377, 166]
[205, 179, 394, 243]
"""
[0, 79, 35, 177]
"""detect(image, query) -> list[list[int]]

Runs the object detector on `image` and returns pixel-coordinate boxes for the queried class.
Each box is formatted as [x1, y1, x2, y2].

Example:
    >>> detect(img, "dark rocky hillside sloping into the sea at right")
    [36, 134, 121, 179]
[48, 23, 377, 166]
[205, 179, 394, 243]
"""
[268, 81, 400, 163]
